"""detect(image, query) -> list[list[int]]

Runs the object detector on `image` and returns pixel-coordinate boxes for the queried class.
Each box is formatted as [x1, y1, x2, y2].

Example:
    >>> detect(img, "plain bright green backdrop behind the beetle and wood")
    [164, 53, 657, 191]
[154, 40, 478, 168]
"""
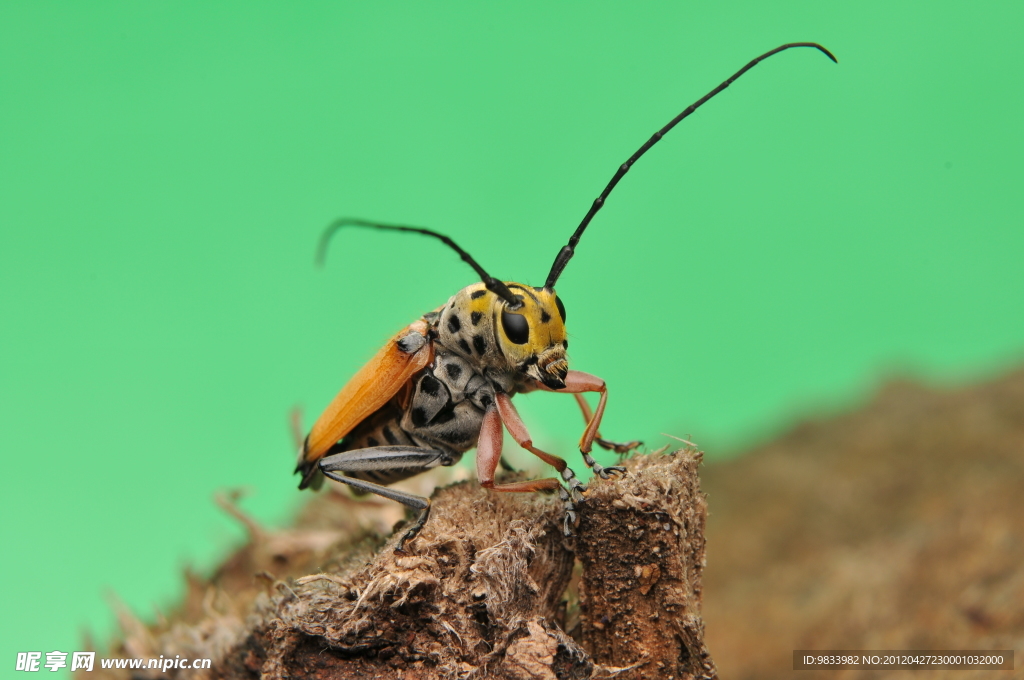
[0, 1, 1024, 668]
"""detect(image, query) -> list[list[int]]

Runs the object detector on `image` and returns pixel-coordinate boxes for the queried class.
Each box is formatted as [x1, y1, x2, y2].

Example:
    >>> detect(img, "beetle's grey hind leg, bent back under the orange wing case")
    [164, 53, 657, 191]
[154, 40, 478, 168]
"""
[319, 447, 456, 552]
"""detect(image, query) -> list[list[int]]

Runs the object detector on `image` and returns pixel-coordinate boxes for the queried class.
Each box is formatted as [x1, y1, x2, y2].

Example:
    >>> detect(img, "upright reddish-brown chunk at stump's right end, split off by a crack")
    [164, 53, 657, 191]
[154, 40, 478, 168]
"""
[577, 453, 717, 680]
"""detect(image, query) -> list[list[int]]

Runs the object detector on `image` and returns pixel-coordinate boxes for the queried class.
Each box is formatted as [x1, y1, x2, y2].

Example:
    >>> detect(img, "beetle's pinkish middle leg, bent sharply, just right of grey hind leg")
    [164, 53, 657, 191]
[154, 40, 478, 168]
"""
[476, 403, 587, 536]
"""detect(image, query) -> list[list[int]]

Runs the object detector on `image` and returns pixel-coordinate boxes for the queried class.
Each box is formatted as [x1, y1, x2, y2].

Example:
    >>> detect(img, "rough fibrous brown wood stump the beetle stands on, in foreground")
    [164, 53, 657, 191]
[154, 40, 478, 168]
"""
[90, 450, 715, 680]
